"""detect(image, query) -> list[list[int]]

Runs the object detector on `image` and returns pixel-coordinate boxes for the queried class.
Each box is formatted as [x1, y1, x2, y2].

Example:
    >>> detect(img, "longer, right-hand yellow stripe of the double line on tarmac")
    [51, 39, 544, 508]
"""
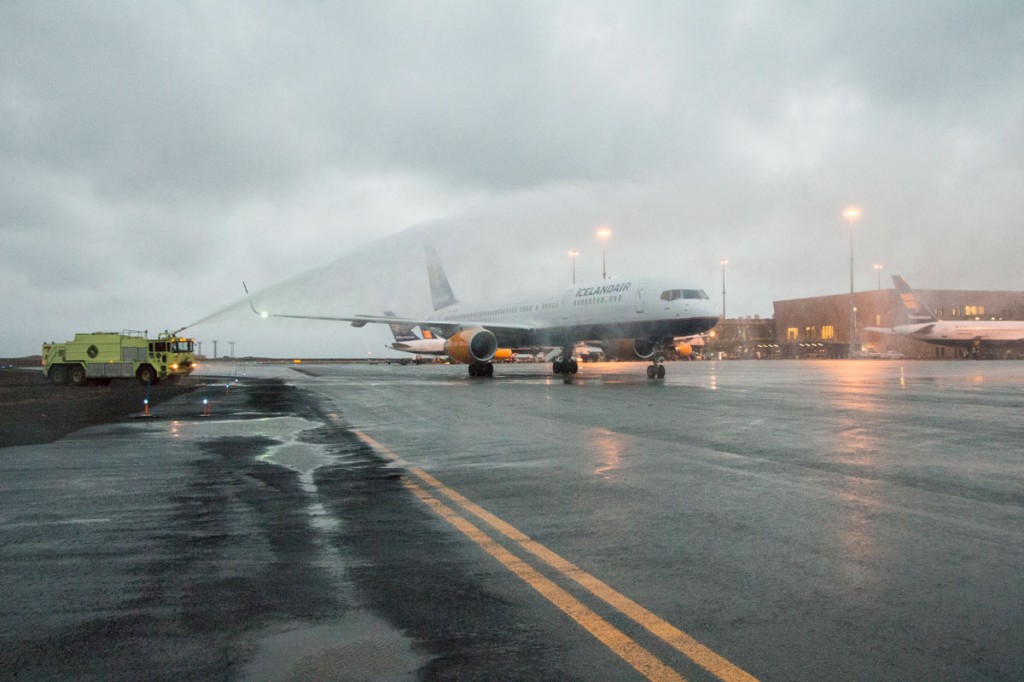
[355, 430, 757, 682]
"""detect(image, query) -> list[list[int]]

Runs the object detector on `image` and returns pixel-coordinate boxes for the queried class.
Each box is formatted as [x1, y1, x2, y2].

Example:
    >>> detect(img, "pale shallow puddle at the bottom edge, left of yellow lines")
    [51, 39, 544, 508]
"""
[239, 611, 430, 682]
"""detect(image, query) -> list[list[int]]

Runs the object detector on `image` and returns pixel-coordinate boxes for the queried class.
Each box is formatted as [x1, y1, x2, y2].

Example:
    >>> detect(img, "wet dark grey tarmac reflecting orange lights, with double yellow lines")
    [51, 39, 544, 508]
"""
[0, 360, 1024, 680]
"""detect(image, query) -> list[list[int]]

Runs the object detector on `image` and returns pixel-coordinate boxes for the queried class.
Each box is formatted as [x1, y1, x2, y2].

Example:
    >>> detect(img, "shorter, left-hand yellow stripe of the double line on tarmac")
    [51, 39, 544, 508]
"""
[401, 476, 685, 682]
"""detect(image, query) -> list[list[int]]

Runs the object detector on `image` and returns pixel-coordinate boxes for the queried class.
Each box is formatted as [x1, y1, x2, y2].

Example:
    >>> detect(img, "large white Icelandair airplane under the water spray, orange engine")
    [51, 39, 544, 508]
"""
[247, 246, 718, 379]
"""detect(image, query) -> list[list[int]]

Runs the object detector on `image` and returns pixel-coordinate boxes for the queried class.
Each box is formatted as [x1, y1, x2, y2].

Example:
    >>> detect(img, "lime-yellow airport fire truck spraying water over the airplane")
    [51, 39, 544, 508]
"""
[43, 330, 196, 386]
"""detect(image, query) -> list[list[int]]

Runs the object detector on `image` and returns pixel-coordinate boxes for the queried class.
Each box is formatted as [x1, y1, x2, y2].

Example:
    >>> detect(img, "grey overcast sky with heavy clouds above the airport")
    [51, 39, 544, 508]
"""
[0, 0, 1024, 356]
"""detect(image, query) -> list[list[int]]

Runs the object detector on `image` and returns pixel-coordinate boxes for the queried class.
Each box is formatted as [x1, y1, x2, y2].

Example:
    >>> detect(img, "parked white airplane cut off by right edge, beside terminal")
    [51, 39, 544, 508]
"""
[864, 274, 1024, 351]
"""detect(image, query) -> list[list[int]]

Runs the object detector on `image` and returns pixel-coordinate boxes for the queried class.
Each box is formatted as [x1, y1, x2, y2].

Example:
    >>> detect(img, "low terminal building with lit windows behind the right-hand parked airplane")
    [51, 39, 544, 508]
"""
[705, 289, 1024, 359]
